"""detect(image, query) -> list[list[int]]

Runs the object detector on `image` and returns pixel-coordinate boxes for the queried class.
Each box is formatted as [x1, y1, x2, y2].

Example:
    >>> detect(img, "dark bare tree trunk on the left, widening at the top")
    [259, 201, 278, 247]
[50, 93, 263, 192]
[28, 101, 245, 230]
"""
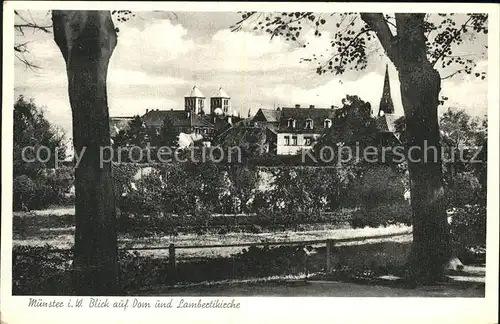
[52, 10, 118, 295]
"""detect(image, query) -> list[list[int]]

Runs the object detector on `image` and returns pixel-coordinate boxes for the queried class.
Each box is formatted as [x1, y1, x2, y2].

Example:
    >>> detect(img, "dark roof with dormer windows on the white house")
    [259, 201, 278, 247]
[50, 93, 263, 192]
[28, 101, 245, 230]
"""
[278, 107, 344, 133]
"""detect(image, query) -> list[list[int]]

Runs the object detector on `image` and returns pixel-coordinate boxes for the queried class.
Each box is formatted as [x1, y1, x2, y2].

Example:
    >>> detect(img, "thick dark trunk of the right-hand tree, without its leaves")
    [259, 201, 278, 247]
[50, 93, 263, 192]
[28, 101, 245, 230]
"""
[395, 14, 451, 283]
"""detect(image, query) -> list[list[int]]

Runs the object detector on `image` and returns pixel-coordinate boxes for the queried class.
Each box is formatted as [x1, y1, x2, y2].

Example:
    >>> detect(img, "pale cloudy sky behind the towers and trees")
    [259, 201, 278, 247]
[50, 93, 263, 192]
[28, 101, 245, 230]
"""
[14, 11, 488, 142]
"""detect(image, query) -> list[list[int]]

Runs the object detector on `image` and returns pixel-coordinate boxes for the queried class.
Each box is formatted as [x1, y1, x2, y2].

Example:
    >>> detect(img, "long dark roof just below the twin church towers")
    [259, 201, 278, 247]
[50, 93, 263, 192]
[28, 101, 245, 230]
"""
[142, 109, 214, 128]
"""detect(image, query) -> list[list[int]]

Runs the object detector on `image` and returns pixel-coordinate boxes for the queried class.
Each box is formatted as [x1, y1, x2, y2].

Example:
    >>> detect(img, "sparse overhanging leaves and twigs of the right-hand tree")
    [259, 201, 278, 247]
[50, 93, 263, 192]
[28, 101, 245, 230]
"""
[232, 11, 488, 79]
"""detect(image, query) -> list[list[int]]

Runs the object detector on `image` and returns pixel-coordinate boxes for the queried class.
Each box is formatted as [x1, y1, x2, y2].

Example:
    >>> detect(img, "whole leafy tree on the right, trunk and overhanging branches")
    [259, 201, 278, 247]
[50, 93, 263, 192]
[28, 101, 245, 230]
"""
[233, 12, 488, 283]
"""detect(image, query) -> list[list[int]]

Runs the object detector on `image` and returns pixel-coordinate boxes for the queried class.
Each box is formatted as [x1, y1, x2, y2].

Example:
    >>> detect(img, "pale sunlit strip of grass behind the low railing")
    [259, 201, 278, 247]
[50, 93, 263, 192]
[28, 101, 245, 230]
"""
[13, 208, 411, 259]
